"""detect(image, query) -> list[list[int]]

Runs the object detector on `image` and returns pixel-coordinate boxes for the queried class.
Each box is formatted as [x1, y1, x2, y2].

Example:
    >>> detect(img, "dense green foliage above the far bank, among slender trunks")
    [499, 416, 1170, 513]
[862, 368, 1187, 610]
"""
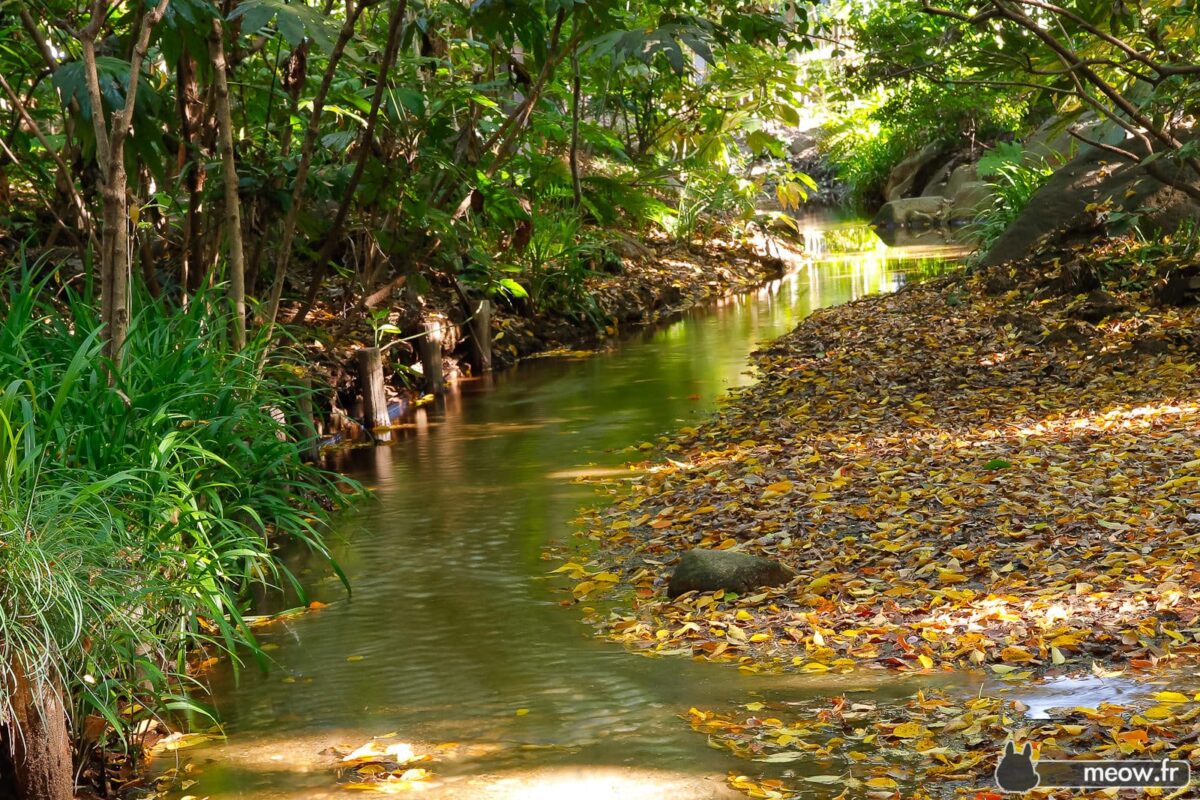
[0, 0, 806, 326]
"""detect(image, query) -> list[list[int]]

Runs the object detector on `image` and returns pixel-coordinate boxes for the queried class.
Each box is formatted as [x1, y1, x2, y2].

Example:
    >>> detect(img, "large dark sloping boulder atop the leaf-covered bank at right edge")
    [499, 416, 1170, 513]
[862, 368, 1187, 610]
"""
[980, 140, 1200, 267]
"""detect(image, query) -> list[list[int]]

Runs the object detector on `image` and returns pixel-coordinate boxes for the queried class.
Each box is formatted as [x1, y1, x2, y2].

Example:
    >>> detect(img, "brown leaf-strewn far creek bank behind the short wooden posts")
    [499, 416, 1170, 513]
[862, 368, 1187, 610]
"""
[292, 237, 785, 438]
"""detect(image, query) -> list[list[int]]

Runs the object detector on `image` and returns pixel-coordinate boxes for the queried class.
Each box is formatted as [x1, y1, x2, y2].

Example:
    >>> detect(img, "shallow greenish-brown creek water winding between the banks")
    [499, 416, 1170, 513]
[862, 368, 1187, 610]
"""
[164, 215, 970, 800]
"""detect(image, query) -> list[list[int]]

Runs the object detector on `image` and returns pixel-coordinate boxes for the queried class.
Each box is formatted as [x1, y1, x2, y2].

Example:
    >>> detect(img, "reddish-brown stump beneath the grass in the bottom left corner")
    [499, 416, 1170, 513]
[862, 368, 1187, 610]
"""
[0, 661, 74, 800]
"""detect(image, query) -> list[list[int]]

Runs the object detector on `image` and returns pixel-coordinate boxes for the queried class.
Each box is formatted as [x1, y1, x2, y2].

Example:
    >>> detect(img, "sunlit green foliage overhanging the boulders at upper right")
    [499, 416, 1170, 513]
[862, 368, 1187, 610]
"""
[825, 0, 1200, 212]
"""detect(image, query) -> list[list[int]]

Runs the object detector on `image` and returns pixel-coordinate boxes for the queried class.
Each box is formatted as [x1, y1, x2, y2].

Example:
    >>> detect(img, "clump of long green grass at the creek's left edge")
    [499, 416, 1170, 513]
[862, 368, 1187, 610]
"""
[0, 262, 355, 762]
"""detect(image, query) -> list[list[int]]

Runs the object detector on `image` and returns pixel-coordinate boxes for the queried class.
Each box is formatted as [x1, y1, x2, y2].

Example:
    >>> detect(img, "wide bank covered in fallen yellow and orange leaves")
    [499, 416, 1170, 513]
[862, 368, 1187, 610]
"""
[565, 231, 1200, 796]
